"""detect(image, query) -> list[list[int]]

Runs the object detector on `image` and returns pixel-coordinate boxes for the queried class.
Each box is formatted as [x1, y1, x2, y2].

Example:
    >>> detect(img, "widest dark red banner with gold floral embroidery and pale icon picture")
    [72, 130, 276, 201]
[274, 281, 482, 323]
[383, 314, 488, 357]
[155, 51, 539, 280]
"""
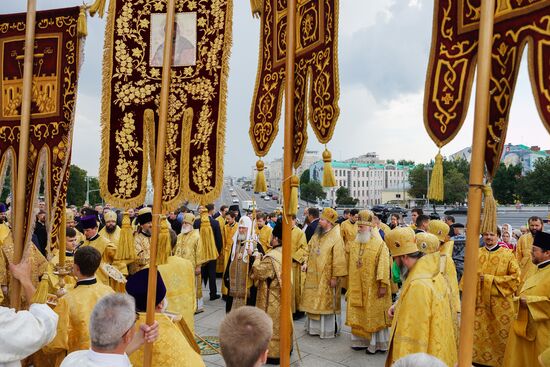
[100, 0, 233, 210]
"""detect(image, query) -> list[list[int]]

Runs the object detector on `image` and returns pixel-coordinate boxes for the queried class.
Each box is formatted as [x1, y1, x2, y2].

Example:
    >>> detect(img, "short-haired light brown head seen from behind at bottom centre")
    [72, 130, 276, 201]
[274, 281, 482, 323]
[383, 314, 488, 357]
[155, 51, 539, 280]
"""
[220, 306, 273, 367]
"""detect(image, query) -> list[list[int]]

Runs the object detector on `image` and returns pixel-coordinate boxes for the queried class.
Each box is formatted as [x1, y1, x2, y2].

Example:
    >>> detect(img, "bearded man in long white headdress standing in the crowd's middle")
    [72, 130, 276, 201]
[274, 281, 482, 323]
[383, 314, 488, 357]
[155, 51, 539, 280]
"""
[223, 217, 256, 312]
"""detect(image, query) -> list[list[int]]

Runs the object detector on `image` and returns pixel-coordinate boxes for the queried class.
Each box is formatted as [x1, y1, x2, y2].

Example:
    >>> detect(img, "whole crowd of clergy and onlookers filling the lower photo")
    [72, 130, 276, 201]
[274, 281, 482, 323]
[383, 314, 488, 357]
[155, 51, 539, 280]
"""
[0, 203, 550, 367]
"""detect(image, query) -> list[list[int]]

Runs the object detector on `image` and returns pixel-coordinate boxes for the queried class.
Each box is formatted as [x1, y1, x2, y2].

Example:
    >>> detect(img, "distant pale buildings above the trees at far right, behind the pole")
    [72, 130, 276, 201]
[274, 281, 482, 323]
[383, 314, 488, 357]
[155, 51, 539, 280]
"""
[449, 144, 550, 175]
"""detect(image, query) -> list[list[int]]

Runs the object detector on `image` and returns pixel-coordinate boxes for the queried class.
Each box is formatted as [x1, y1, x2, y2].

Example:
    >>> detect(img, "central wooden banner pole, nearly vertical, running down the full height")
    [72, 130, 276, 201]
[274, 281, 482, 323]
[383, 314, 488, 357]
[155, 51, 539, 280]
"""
[280, 0, 296, 367]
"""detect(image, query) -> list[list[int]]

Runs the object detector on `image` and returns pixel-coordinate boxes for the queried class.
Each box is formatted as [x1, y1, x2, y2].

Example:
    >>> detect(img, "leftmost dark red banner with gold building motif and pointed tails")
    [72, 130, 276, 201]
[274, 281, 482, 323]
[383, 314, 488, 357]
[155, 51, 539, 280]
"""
[0, 7, 86, 252]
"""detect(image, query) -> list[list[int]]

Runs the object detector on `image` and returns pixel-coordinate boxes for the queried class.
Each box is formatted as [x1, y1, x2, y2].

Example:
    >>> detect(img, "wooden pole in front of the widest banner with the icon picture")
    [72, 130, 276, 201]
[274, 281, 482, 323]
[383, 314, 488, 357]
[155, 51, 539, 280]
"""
[143, 0, 176, 367]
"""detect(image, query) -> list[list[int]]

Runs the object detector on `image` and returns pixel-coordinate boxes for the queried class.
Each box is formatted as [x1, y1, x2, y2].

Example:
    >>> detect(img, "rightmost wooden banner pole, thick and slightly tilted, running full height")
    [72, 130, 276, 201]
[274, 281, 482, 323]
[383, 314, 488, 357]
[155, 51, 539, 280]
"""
[458, 0, 495, 367]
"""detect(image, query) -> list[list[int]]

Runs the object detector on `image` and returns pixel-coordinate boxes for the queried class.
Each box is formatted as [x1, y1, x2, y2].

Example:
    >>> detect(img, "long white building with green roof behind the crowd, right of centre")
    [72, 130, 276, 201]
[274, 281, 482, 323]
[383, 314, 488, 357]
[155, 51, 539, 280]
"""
[309, 160, 413, 207]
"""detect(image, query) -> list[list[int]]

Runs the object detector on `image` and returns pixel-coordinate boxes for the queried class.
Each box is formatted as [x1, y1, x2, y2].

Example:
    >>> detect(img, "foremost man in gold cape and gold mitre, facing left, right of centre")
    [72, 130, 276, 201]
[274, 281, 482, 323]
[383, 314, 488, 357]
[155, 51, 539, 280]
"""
[385, 227, 457, 367]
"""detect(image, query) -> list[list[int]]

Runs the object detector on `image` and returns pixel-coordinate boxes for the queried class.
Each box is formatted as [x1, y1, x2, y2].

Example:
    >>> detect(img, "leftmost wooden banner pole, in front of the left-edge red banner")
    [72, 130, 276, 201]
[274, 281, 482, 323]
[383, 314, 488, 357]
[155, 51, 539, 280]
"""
[10, 0, 36, 310]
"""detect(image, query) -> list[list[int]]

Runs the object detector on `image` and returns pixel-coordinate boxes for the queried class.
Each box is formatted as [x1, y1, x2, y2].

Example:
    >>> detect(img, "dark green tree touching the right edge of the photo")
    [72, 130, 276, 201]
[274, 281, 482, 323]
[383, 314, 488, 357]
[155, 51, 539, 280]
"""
[521, 157, 550, 204]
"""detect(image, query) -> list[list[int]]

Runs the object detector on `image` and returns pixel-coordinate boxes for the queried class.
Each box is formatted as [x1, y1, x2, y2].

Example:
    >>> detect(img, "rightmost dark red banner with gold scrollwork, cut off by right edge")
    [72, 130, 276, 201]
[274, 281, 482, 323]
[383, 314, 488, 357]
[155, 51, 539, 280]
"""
[424, 0, 550, 177]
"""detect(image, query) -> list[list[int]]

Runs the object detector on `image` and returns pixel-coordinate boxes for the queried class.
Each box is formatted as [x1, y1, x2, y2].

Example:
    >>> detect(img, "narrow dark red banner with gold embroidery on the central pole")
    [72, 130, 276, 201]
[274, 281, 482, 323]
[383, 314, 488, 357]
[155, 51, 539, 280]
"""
[249, 0, 340, 167]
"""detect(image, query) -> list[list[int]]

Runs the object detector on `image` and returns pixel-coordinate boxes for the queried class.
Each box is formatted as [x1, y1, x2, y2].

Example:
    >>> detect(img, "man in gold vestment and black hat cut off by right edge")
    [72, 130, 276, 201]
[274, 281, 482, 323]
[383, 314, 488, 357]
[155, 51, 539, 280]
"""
[504, 232, 550, 367]
